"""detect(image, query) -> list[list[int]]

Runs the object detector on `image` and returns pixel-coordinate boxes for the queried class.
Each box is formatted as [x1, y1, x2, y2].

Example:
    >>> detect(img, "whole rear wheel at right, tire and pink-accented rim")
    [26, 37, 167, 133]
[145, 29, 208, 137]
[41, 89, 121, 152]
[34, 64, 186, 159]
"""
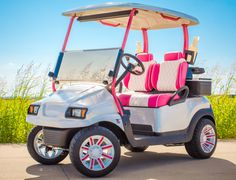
[185, 119, 217, 159]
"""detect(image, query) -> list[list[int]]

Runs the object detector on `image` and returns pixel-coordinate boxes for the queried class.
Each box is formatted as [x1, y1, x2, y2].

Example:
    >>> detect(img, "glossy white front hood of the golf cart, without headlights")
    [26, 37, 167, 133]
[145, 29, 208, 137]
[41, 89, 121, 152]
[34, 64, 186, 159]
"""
[27, 84, 123, 128]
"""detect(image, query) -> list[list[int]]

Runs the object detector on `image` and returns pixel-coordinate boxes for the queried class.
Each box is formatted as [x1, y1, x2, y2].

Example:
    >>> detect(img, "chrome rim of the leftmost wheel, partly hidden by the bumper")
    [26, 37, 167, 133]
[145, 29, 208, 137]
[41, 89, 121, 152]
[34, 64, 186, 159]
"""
[34, 130, 63, 159]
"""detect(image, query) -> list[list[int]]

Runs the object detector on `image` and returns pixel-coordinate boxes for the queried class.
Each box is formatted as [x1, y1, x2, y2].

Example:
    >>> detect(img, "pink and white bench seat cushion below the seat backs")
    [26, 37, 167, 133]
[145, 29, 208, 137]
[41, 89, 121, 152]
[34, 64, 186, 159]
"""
[118, 92, 179, 108]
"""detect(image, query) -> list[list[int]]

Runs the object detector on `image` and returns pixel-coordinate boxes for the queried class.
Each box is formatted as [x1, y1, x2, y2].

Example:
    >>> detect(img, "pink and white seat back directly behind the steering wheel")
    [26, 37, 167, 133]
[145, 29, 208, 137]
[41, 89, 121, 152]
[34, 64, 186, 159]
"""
[124, 53, 155, 92]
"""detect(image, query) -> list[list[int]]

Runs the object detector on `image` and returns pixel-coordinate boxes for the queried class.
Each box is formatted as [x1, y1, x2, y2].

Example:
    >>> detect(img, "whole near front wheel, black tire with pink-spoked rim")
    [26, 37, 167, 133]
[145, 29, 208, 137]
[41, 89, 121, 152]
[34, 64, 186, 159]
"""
[70, 126, 120, 177]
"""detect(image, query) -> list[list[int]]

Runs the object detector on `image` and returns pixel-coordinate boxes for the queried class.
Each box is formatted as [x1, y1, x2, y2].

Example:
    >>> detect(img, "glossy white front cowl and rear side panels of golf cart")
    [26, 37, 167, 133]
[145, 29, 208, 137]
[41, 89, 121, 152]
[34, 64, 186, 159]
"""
[27, 84, 210, 133]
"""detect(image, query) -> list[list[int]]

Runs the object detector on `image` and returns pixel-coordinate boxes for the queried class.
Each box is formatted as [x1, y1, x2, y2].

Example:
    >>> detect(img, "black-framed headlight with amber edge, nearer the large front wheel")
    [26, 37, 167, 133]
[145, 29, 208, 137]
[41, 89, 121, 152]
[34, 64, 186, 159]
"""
[66, 107, 88, 119]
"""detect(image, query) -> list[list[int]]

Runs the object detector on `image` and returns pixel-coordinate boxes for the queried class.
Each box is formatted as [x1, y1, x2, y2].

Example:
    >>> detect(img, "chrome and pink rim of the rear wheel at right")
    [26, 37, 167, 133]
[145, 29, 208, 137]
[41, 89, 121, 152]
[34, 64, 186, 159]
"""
[200, 124, 216, 153]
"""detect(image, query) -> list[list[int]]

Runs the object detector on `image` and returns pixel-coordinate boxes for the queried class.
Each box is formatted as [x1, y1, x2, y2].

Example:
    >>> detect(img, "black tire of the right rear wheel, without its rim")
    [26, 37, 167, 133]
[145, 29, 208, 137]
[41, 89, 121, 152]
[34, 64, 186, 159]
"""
[185, 118, 217, 159]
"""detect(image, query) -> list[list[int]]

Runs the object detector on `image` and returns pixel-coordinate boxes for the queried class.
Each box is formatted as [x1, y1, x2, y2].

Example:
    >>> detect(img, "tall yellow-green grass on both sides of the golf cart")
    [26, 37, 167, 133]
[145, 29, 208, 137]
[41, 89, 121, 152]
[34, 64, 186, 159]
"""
[0, 64, 236, 143]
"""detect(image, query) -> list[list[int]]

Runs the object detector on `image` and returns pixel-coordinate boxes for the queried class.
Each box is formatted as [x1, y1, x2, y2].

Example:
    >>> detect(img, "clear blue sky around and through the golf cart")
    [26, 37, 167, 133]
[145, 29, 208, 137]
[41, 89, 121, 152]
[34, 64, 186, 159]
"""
[0, 0, 236, 83]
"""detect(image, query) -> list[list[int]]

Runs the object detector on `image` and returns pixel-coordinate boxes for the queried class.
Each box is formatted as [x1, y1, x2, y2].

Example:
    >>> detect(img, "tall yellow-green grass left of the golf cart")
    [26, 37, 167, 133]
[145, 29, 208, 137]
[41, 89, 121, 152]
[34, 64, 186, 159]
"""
[0, 63, 48, 143]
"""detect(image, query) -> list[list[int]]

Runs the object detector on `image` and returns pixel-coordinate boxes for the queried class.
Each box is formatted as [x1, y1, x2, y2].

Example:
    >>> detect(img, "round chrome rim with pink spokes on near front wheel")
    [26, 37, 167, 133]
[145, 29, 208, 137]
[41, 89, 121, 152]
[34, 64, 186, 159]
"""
[79, 135, 115, 171]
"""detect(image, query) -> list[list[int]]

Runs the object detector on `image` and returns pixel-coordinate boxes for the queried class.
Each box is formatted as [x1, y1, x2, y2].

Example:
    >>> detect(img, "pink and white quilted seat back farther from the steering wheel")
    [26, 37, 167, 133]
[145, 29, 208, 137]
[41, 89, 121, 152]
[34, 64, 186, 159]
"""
[151, 53, 188, 91]
